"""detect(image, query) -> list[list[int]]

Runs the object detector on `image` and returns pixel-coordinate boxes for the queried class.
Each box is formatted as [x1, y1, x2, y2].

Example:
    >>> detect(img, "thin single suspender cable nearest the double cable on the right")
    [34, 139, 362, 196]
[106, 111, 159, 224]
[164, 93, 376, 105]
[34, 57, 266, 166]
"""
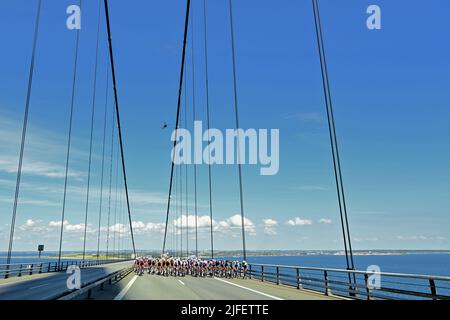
[229, 0, 247, 260]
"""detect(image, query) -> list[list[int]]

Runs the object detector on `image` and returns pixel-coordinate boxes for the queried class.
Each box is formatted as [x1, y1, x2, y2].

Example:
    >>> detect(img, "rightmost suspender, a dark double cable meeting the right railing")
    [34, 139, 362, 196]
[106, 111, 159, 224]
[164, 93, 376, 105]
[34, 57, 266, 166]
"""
[312, 0, 355, 270]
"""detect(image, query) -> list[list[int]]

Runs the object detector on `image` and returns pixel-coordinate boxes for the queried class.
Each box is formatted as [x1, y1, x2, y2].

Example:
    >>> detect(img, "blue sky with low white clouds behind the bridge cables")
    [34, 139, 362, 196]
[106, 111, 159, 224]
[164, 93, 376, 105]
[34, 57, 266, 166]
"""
[0, 0, 450, 251]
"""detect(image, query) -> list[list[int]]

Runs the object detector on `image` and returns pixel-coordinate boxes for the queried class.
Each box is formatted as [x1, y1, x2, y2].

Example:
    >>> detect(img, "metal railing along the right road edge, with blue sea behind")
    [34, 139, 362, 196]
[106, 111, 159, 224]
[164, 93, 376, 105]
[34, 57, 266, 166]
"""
[247, 264, 450, 300]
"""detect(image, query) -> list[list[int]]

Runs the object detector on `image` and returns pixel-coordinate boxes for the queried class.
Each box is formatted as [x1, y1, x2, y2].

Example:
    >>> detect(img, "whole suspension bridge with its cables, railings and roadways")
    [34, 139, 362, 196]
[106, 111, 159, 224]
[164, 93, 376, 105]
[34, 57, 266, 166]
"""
[0, 0, 450, 300]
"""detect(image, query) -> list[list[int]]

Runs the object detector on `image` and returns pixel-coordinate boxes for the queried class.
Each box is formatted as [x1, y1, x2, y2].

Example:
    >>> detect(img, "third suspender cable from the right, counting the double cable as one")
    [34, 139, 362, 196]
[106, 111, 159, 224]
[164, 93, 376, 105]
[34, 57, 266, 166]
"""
[203, 0, 214, 259]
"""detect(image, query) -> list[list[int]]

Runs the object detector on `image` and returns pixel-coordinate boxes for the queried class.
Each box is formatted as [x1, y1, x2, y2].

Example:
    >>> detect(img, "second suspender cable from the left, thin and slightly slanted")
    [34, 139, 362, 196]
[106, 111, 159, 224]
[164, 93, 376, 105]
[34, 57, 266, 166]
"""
[83, 1, 102, 261]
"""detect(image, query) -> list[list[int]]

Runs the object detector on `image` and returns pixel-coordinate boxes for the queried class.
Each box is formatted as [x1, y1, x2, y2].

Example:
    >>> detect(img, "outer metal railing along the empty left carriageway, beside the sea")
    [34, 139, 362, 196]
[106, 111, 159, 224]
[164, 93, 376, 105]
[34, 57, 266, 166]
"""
[0, 259, 127, 279]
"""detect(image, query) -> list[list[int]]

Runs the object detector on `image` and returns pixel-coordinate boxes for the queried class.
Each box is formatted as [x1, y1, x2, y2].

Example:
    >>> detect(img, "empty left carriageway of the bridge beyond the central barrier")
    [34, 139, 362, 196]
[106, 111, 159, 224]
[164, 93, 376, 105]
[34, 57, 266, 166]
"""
[0, 262, 132, 300]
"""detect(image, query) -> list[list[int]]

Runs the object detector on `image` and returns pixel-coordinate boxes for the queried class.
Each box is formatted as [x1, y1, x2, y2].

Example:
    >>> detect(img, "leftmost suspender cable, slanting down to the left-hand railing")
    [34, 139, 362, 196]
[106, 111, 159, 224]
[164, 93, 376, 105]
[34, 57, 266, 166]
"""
[6, 0, 41, 269]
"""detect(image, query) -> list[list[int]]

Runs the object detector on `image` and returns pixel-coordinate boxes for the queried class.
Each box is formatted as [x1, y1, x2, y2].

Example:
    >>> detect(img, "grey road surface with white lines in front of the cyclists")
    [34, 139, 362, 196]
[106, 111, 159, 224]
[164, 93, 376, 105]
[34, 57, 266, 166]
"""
[87, 273, 338, 300]
